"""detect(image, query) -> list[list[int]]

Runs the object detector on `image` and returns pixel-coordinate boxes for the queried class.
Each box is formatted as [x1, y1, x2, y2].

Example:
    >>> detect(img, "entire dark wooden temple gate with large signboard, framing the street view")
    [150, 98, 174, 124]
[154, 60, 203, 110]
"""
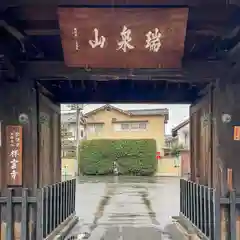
[0, 0, 240, 240]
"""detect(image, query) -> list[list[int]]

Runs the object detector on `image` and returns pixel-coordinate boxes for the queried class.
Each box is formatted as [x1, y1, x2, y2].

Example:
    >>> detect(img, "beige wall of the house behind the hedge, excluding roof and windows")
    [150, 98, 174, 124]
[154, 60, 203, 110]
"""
[87, 109, 165, 152]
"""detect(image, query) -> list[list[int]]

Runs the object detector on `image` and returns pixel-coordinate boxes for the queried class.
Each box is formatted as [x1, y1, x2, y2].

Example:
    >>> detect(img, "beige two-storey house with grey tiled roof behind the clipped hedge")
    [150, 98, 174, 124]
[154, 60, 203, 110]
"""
[84, 104, 169, 152]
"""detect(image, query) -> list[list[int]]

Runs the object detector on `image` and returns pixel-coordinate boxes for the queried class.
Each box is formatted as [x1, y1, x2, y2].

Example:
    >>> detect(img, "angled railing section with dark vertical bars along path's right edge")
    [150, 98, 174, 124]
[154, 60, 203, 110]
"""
[180, 179, 220, 240]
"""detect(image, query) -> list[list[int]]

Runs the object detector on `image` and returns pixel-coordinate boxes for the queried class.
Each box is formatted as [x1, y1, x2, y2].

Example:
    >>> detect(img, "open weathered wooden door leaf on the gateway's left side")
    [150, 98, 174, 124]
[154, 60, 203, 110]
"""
[39, 91, 61, 187]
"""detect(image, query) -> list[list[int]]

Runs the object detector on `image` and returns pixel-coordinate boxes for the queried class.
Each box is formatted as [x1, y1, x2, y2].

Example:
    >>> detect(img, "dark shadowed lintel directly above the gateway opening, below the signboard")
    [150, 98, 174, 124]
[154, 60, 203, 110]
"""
[40, 80, 200, 104]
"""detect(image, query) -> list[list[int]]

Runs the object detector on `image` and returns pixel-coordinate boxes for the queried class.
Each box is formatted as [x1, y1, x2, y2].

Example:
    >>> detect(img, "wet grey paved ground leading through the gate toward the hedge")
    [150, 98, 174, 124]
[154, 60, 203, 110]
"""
[66, 177, 179, 240]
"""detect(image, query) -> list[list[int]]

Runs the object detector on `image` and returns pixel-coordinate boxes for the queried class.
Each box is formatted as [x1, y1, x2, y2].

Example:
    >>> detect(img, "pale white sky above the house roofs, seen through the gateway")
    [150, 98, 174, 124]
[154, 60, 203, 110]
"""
[61, 104, 190, 134]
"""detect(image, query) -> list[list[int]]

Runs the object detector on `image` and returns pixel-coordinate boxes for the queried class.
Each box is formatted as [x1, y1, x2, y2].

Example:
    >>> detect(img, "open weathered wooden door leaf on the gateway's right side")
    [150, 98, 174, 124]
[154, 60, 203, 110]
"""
[190, 88, 213, 187]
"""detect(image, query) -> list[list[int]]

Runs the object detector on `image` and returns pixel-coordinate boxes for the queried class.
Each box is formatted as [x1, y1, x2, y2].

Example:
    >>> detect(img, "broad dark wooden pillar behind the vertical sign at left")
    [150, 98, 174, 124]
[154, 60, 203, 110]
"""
[0, 80, 38, 239]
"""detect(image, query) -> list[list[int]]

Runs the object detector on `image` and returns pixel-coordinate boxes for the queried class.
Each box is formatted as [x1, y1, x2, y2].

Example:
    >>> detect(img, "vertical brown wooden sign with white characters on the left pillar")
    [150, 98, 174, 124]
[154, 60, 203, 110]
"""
[6, 125, 23, 186]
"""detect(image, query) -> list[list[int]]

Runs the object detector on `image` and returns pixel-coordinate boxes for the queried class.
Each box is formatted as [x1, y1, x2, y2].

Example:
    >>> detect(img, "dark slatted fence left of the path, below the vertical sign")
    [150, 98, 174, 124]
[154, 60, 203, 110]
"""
[0, 179, 76, 240]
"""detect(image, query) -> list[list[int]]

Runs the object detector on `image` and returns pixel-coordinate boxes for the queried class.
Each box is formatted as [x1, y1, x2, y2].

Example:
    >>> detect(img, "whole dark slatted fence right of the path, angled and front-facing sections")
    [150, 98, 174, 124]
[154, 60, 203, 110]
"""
[180, 179, 240, 240]
